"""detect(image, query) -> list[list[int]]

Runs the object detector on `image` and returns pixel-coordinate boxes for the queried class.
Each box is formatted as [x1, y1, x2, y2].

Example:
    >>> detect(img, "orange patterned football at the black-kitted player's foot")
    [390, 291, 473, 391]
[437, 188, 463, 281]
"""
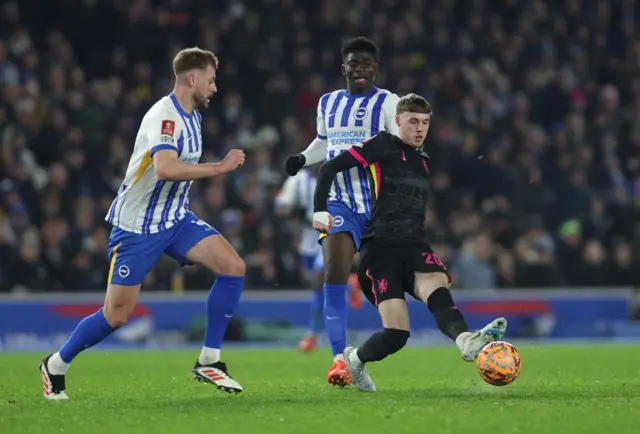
[476, 341, 522, 386]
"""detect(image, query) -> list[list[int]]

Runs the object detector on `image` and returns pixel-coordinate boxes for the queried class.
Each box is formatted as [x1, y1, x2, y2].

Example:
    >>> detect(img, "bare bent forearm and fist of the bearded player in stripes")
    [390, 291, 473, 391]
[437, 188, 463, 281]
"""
[153, 149, 245, 181]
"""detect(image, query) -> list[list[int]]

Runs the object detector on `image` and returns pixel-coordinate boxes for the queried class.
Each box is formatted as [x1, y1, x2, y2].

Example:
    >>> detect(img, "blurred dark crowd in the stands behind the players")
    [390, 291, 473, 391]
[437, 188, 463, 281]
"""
[0, 0, 640, 292]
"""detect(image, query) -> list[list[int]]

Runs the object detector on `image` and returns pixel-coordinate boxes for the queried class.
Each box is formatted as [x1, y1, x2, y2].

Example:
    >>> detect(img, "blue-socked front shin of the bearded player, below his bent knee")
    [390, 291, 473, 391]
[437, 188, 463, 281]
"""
[198, 274, 244, 365]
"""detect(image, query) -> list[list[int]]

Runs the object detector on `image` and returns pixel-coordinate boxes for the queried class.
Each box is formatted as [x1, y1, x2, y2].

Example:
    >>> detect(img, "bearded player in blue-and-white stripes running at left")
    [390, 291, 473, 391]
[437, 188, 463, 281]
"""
[40, 47, 245, 400]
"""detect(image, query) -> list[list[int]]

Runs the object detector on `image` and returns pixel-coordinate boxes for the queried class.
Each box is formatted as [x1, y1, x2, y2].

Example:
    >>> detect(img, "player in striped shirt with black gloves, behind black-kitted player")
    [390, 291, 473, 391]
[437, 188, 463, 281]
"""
[285, 37, 399, 386]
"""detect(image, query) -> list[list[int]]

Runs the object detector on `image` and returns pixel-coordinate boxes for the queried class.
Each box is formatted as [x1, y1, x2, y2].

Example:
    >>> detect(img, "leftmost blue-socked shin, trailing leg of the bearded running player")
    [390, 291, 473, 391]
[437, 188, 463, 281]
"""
[53, 308, 115, 375]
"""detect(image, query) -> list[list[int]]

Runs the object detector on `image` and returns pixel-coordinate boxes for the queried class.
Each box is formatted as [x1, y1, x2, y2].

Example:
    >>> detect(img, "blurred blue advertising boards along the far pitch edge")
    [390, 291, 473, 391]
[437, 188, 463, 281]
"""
[0, 289, 640, 351]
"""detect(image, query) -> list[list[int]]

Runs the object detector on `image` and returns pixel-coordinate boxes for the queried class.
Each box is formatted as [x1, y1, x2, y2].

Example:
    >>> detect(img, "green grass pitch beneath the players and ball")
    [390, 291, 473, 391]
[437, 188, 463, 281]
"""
[0, 345, 640, 434]
